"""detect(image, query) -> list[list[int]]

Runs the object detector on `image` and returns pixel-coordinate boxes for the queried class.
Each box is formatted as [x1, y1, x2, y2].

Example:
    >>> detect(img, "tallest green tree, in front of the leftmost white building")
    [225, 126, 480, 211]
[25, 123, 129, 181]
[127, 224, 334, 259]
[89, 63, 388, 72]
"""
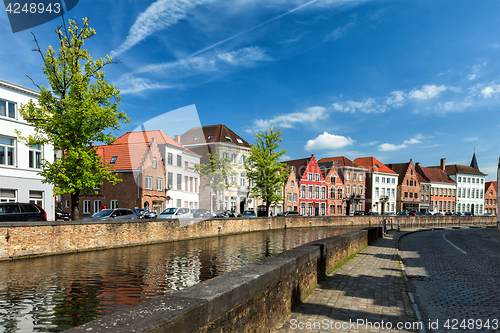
[17, 18, 129, 219]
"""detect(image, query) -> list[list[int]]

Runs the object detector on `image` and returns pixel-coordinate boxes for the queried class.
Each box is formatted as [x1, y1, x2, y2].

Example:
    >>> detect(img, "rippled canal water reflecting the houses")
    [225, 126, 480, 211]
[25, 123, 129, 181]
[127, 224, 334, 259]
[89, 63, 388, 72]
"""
[0, 224, 358, 333]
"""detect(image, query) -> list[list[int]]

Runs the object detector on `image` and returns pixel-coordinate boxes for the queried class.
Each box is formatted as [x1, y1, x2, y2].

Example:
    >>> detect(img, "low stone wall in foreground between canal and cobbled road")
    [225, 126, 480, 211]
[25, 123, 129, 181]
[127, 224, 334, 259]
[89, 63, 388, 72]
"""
[65, 227, 382, 333]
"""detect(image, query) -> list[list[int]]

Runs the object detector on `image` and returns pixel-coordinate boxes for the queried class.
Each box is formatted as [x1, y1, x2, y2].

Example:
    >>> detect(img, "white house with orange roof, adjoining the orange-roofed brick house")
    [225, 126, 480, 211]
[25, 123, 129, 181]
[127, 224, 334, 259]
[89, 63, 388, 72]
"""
[114, 130, 201, 209]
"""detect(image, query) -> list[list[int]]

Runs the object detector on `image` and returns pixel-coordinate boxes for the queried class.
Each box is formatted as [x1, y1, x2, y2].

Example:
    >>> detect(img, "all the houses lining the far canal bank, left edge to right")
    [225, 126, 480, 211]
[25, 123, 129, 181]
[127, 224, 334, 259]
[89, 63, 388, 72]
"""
[0, 80, 497, 220]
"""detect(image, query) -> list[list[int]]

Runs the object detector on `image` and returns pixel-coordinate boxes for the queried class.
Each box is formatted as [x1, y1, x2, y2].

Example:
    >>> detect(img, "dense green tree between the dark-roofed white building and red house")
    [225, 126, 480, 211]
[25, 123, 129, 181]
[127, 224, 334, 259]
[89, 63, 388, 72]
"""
[245, 126, 289, 211]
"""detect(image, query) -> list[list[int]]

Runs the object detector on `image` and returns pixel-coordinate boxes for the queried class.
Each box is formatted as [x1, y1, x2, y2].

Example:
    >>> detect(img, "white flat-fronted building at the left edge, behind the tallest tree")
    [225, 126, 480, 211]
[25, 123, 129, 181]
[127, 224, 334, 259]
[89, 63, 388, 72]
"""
[0, 80, 55, 221]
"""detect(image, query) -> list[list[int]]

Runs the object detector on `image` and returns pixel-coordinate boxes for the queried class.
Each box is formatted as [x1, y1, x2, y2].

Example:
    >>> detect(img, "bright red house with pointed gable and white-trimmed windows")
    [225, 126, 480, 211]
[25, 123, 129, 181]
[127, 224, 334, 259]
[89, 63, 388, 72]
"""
[284, 154, 327, 216]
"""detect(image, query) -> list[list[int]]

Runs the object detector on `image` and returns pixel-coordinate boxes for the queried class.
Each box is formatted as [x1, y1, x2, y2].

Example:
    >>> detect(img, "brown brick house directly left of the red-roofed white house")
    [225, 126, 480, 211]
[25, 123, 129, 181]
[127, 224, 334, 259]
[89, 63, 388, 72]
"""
[318, 156, 367, 215]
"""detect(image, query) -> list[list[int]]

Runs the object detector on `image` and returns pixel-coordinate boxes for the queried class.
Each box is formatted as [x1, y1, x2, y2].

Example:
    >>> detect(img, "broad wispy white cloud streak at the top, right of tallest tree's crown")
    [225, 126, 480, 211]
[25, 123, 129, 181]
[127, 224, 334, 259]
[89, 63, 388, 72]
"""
[110, 0, 209, 57]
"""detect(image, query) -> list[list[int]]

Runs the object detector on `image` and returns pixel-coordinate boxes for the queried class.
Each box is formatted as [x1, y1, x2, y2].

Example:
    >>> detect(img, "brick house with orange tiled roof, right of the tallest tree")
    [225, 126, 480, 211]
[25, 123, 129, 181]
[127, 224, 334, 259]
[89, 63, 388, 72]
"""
[63, 138, 166, 218]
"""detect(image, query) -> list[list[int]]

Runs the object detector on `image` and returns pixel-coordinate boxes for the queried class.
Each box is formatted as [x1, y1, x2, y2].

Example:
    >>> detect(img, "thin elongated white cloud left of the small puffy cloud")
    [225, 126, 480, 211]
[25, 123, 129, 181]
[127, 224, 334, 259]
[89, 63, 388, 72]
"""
[247, 106, 328, 132]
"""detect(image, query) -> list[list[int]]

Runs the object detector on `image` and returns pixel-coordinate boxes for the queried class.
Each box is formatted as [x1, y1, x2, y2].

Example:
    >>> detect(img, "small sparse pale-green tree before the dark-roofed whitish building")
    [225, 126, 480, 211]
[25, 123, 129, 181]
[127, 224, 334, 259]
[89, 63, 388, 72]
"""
[193, 154, 236, 212]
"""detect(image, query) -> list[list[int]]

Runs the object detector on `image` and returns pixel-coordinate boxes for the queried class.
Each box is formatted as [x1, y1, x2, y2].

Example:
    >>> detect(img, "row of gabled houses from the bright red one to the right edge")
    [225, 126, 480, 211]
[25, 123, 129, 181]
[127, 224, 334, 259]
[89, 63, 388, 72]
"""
[277, 153, 497, 215]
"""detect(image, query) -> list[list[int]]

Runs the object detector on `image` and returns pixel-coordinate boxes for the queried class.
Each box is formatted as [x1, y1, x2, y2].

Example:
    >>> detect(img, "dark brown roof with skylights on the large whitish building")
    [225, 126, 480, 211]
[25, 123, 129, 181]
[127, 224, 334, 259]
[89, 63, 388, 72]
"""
[181, 124, 250, 148]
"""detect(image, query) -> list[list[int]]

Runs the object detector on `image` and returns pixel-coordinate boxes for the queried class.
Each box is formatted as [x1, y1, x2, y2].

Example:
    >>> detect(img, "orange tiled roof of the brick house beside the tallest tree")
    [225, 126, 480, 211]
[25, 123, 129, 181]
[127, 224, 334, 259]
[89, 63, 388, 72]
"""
[96, 143, 149, 171]
